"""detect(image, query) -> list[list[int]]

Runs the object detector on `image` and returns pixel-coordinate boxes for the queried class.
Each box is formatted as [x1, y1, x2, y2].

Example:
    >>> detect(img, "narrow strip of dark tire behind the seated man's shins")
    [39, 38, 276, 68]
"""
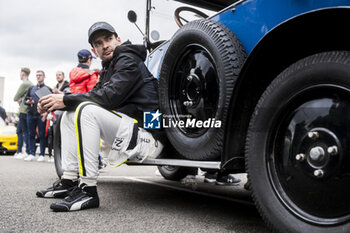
[53, 114, 63, 178]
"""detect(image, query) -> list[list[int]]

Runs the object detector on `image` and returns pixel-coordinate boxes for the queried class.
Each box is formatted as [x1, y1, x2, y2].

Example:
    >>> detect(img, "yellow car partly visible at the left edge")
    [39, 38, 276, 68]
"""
[0, 118, 17, 154]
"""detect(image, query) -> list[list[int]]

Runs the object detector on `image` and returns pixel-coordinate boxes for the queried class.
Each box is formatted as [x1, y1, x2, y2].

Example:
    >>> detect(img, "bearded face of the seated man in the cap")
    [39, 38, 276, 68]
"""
[91, 31, 121, 61]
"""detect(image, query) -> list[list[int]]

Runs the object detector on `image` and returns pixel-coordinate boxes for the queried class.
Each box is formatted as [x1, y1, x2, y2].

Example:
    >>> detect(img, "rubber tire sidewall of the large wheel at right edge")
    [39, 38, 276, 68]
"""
[246, 55, 350, 232]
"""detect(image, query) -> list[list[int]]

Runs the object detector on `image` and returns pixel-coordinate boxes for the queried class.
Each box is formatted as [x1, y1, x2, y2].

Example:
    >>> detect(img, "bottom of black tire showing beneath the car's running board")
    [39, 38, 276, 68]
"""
[158, 166, 198, 181]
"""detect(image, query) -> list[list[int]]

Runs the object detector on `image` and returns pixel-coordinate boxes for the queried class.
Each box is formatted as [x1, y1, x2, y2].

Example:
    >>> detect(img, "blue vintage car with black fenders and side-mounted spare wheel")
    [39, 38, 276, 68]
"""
[137, 0, 350, 232]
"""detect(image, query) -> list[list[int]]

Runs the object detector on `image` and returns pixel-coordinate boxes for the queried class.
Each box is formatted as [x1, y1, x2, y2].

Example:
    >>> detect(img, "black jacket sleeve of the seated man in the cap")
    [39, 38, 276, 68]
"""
[63, 54, 143, 110]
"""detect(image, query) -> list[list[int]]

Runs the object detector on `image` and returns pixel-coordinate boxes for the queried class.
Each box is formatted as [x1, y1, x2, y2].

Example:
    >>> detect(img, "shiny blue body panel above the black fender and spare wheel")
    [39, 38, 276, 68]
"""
[211, 0, 350, 54]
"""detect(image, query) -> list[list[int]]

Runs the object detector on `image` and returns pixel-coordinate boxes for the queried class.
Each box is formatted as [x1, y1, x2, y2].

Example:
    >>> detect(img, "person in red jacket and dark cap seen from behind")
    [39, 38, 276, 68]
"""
[69, 49, 98, 93]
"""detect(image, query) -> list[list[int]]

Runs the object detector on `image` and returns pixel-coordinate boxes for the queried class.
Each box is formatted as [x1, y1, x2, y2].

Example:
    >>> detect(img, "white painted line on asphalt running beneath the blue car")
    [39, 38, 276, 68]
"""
[99, 176, 254, 206]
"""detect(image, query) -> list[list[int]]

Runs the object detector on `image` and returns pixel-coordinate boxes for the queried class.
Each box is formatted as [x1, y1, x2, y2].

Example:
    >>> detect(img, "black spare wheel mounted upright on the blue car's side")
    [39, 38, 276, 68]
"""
[159, 20, 246, 160]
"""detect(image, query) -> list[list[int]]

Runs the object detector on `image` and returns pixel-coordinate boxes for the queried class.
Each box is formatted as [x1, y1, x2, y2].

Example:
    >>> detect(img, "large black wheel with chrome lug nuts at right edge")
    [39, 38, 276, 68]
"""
[246, 51, 350, 233]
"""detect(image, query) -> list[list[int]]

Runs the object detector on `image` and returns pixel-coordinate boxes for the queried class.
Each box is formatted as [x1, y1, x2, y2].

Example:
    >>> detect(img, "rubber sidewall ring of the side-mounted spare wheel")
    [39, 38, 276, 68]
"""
[159, 20, 243, 159]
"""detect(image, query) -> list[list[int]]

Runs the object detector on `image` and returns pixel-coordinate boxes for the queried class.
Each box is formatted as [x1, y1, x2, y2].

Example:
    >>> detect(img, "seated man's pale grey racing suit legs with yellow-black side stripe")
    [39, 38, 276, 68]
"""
[61, 102, 163, 186]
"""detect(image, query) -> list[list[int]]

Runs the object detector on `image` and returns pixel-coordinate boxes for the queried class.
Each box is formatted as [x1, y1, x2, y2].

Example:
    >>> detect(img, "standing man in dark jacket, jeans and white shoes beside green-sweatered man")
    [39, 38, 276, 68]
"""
[24, 70, 51, 162]
